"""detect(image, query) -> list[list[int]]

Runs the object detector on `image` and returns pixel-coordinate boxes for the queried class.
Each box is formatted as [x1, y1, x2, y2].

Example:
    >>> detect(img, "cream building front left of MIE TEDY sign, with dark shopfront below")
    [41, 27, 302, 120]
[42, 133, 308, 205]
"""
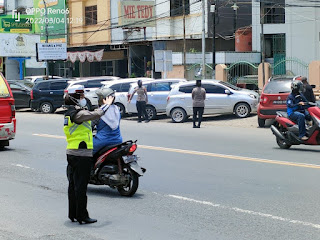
[64, 0, 127, 77]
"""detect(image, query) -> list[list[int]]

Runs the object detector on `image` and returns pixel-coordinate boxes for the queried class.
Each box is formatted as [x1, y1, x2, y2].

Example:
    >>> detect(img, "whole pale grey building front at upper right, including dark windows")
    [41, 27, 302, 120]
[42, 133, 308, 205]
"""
[252, 0, 320, 70]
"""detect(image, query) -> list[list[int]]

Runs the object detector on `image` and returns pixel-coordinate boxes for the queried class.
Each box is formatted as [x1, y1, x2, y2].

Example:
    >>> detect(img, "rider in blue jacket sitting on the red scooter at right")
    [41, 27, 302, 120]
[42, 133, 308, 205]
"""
[287, 80, 311, 141]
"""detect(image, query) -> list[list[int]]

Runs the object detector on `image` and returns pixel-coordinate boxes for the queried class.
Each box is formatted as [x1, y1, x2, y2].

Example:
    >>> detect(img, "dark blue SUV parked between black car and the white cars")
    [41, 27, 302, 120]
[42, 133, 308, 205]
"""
[31, 79, 70, 113]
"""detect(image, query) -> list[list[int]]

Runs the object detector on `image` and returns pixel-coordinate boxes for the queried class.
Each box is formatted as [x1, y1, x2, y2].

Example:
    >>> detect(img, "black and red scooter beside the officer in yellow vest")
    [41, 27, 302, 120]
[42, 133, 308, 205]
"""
[89, 140, 146, 197]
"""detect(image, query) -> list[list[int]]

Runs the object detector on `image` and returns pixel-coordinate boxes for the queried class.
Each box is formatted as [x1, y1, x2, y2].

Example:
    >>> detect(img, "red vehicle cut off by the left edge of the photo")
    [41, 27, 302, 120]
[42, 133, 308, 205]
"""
[0, 73, 16, 149]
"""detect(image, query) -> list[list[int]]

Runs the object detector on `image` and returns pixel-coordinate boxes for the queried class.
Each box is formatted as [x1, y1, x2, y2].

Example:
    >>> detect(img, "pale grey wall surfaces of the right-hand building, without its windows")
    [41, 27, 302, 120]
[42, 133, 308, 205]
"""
[252, 0, 320, 64]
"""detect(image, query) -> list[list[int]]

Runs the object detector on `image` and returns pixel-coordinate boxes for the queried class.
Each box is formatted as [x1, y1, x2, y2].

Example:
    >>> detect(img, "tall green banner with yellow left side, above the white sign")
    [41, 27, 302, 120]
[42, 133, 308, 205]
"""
[32, 0, 68, 43]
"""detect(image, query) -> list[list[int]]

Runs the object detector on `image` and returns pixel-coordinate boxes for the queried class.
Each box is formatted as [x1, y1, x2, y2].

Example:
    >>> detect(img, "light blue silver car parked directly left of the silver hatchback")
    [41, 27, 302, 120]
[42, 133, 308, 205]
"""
[127, 78, 187, 119]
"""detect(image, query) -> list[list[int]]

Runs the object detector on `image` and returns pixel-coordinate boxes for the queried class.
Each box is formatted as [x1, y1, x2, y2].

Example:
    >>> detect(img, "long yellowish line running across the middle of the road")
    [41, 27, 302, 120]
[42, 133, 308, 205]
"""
[32, 133, 320, 169]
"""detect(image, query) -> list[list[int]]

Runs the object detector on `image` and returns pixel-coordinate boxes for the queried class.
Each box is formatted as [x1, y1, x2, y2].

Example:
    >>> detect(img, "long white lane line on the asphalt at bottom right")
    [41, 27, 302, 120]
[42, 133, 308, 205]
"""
[166, 195, 320, 229]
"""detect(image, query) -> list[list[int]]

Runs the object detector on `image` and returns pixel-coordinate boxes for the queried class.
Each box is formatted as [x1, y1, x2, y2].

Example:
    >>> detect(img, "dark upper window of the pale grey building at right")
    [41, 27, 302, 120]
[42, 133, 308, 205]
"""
[262, 0, 285, 24]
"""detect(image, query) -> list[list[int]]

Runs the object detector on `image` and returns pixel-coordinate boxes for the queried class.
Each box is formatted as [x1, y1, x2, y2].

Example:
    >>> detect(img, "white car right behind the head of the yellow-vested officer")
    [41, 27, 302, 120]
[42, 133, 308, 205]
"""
[67, 76, 119, 110]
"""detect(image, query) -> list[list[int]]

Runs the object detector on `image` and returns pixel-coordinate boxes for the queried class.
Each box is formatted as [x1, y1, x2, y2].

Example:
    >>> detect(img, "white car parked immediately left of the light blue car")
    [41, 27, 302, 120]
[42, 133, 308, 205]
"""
[101, 78, 154, 116]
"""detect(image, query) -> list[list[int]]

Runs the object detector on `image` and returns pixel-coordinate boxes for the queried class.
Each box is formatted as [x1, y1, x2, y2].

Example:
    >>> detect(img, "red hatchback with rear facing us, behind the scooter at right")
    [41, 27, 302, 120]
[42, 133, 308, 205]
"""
[257, 77, 295, 127]
